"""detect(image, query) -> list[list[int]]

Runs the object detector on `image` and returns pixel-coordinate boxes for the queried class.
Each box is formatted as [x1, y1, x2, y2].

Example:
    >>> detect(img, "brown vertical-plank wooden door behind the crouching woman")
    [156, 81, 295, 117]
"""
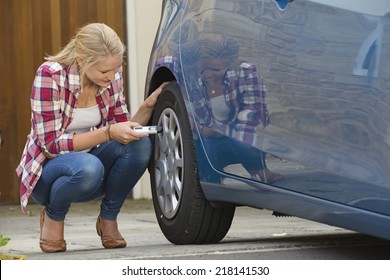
[0, 0, 126, 204]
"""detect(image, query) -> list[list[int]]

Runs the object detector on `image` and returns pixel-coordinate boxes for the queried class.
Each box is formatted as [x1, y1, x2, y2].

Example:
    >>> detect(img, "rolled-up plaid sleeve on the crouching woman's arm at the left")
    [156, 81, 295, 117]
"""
[31, 66, 73, 158]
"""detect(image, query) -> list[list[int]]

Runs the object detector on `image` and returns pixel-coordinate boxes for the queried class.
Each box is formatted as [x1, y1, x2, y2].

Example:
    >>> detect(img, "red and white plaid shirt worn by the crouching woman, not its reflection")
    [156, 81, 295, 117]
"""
[16, 62, 131, 213]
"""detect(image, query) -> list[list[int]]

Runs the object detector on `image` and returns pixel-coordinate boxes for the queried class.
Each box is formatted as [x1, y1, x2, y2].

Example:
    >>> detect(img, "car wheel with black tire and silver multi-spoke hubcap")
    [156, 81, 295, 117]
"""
[150, 82, 235, 244]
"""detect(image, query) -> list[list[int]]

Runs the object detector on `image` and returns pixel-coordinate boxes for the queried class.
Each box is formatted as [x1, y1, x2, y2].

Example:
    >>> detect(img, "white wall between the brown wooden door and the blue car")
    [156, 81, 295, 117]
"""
[126, 0, 162, 199]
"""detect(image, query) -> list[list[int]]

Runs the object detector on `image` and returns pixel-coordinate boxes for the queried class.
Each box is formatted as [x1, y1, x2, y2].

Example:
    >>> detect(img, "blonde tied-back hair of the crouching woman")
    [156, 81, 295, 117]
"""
[45, 23, 125, 81]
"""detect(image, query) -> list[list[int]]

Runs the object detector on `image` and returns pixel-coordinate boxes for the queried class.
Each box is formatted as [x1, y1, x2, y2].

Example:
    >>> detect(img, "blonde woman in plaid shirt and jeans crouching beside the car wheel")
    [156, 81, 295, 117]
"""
[16, 23, 162, 252]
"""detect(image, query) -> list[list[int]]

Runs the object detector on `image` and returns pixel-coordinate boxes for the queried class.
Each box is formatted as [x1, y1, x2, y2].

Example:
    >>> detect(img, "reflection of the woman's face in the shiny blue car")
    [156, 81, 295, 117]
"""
[196, 57, 226, 83]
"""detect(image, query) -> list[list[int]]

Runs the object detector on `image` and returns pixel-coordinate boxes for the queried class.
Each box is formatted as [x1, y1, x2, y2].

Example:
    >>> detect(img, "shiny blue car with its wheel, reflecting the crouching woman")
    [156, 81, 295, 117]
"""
[145, 0, 390, 244]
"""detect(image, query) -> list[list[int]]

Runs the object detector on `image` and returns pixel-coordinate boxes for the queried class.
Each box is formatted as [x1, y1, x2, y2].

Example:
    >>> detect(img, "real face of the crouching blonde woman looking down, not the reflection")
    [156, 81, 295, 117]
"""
[85, 55, 122, 88]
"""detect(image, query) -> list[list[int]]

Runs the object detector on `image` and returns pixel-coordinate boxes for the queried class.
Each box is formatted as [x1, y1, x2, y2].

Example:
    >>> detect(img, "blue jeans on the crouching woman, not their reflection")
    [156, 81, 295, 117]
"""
[32, 137, 152, 221]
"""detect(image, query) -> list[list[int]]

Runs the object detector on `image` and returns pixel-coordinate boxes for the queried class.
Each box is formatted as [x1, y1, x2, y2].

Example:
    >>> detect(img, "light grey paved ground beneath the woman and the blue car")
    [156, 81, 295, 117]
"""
[0, 197, 356, 260]
